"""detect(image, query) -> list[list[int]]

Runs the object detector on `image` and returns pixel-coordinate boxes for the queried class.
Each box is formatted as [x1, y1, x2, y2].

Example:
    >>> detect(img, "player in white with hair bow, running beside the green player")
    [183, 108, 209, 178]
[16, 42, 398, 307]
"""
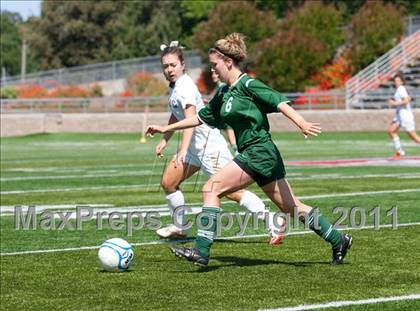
[156, 41, 284, 245]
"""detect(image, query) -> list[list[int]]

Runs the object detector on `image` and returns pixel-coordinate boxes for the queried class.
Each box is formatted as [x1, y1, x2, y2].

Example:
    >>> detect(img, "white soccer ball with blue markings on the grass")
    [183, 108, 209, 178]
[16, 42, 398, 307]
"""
[98, 238, 134, 272]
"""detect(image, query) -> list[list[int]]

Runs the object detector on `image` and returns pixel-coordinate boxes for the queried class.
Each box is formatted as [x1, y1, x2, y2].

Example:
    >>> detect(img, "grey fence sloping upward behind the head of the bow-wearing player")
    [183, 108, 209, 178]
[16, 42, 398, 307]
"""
[1, 51, 202, 88]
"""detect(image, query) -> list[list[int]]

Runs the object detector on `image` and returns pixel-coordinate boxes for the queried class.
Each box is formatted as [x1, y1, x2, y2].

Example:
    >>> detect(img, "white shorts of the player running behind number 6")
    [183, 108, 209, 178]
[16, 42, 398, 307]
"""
[185, 143, 233, 176]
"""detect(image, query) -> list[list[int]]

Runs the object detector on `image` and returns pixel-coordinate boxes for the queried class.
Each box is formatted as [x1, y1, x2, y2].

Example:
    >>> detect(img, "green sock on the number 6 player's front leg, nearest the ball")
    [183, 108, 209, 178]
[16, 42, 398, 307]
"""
[195, 207, 220, 257]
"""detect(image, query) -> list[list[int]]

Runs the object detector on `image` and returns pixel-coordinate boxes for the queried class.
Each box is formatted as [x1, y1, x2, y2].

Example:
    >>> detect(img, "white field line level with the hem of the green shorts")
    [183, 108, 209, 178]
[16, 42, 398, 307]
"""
[0, 170, 420, 186]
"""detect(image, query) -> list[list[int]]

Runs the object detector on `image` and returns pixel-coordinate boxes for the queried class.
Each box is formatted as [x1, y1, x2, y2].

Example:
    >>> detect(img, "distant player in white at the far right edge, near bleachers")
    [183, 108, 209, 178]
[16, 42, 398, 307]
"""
[388, 74, 420, 159]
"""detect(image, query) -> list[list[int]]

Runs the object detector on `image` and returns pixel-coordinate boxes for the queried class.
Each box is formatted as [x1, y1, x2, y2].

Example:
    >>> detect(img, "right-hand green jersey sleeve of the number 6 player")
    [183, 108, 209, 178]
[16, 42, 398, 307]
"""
[245, 79, 290, 113]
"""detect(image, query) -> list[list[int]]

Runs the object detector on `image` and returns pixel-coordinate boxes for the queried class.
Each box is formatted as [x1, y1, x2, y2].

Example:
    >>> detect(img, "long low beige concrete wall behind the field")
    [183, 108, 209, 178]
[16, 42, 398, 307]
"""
[1, 109, 420, 137]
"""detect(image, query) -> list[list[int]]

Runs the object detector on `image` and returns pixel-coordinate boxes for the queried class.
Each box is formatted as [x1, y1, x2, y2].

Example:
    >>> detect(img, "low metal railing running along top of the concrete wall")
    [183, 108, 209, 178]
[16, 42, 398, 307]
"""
[4, 90, 420, 114]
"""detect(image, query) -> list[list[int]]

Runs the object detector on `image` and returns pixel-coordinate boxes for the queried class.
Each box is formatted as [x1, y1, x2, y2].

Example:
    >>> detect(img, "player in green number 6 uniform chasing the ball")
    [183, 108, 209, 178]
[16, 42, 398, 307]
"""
[147, 33, 352, 266]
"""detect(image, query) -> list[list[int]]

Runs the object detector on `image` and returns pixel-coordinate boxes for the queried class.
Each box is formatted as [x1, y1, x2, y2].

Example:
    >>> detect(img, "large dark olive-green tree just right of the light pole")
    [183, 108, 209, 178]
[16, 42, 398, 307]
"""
[28, 0, 124, 69]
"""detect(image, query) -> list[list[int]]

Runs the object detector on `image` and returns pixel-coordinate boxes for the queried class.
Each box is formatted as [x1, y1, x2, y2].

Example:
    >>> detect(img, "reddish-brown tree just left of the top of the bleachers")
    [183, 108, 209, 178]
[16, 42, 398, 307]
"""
[350, 1, 404, 72]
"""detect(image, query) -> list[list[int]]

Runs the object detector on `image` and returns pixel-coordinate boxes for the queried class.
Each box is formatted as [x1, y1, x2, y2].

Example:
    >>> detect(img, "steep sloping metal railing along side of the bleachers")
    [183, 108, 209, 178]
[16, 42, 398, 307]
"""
[346, 30, 420, 109]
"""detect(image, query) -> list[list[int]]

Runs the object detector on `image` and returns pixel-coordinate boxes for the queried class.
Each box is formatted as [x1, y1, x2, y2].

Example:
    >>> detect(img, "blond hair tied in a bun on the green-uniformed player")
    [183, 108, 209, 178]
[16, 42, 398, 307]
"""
[209, 32, 247, 64]
